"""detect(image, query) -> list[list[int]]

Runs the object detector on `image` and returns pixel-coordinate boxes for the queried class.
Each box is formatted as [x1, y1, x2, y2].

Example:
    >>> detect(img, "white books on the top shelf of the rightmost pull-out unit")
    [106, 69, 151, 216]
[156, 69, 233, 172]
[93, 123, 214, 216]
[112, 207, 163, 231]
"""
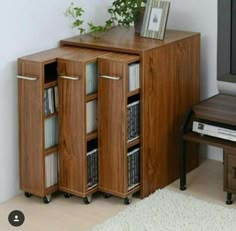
[128, 63, 140, 91]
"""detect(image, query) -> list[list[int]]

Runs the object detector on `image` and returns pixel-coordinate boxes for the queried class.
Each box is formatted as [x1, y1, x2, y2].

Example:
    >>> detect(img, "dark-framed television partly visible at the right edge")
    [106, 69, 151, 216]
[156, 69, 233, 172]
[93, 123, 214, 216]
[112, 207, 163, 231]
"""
[217, 0, 236, 96]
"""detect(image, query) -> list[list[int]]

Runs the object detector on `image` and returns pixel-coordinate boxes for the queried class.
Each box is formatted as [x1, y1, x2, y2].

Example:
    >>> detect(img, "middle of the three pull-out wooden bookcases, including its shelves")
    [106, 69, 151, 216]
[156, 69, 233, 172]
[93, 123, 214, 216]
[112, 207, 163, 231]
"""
[58, 49, 107, 203]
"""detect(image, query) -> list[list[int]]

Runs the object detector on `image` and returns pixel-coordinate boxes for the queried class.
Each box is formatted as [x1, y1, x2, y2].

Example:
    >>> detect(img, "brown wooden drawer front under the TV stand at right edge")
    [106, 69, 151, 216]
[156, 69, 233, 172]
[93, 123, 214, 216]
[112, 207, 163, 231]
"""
[224, 152, 236, 190]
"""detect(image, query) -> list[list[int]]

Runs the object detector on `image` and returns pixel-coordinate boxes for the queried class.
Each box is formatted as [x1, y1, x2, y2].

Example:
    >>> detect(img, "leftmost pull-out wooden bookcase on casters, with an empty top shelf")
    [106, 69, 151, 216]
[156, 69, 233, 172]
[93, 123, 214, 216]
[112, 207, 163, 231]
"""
[17, 47, 78, 203]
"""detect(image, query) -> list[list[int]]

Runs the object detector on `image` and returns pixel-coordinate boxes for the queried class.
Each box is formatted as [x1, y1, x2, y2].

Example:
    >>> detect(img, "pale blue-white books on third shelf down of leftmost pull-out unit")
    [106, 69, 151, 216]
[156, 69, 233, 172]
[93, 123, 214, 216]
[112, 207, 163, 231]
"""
[44, 115, 58, 149]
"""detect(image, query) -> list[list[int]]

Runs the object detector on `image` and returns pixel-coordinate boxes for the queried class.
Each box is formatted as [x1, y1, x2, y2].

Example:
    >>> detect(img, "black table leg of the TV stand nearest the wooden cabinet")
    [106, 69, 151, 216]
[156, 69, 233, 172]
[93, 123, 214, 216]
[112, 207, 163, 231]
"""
[180, 140, 187, 191]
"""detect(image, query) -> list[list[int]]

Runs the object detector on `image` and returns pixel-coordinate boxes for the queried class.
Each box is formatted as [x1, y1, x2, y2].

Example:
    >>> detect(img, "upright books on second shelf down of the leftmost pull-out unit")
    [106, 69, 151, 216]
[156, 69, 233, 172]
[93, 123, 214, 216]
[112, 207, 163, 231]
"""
[44, 86, 58, 115]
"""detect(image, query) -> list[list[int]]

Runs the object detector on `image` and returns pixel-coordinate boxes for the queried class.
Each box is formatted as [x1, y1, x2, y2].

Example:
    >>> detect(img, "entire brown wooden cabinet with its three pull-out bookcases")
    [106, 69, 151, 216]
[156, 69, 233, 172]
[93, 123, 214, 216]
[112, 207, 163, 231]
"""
[18, 27, 200, 202]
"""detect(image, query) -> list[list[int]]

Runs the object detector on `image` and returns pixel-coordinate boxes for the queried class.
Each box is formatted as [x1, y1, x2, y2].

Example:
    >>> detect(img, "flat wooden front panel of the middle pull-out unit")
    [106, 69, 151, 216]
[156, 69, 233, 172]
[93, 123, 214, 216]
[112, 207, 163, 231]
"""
[58, 59, 86, 191]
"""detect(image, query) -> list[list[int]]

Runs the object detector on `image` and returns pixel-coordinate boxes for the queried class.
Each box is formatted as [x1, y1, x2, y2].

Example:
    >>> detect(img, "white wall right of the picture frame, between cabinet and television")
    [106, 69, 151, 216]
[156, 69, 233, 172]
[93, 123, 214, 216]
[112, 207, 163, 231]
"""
[167, 0, 222, 160]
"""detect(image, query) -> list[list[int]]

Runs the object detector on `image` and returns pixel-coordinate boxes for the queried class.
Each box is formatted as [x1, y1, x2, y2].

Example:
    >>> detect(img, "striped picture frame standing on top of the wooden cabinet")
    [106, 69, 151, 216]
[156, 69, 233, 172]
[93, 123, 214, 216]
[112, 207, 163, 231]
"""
[141, 0, 170, 40]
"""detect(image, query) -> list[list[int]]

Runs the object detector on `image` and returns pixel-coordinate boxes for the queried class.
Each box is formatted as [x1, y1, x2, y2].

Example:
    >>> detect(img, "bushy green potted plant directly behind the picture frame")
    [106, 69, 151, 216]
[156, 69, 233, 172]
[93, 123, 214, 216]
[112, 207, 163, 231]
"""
[108, 0, 146, 32]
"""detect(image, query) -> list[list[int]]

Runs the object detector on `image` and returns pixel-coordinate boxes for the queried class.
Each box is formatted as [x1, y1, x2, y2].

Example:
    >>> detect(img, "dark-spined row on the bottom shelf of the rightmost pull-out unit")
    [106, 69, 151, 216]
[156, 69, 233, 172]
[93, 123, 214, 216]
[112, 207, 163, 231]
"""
[128, 148, 140, 190]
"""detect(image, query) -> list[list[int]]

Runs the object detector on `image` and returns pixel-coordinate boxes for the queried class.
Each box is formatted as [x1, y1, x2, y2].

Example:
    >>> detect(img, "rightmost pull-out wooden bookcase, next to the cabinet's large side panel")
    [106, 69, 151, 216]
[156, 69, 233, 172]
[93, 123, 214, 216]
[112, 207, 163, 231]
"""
[98, 53, 140, 203]
